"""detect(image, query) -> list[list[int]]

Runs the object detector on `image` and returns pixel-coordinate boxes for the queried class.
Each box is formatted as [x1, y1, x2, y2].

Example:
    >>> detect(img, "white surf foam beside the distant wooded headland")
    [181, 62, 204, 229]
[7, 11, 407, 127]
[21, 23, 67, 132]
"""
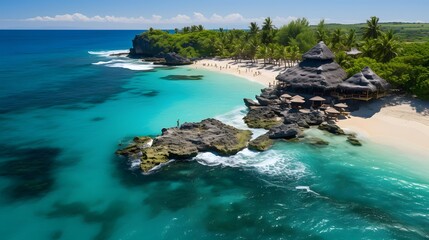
[88, 50, 155, 71]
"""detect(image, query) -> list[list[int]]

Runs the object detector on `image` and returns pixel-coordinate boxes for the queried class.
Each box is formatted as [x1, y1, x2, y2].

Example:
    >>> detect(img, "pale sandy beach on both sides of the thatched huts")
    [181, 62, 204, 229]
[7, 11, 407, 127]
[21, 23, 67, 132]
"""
[194, 59, 429, 161]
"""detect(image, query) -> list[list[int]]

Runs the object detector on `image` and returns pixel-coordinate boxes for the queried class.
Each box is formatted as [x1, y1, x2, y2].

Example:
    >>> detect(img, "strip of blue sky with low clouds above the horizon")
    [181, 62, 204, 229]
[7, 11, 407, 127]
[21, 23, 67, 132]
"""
[0, 0, 429, 29]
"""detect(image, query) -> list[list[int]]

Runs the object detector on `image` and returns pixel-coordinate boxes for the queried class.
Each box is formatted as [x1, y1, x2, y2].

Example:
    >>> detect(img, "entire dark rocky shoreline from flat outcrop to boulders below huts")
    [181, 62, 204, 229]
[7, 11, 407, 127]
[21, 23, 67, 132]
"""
[116, 85, 362, 173]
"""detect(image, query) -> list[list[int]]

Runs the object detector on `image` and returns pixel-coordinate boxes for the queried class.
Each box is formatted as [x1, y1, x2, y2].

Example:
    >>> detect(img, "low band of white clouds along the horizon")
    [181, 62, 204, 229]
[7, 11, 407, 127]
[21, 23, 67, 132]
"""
[23, 12, 296, 26]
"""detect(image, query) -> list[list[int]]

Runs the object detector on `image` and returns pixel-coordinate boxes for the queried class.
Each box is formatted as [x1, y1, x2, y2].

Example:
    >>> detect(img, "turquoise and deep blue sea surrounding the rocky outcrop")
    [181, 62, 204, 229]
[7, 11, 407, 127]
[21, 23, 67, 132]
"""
[0, 31, 429, 239]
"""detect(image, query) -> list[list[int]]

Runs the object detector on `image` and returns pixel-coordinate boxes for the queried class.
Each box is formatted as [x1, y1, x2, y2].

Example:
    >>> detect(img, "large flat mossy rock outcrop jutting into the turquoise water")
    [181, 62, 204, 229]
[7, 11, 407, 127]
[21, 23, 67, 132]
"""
[116, 119, 252, 172]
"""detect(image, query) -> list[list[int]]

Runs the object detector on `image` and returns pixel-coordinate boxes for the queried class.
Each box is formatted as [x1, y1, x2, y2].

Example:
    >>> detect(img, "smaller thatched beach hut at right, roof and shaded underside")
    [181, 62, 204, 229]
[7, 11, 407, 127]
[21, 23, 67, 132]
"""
[336, 67, 389, 101]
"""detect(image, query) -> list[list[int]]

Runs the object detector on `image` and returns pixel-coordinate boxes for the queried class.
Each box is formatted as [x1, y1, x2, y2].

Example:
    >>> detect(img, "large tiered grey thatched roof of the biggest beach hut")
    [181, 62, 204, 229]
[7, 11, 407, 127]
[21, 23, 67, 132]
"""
[276, 42, 347, 93]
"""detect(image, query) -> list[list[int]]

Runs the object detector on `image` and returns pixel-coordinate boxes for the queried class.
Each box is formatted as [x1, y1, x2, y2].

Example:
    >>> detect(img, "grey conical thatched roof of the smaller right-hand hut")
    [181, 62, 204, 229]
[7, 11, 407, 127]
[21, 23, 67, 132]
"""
[338, 67, 389, 92]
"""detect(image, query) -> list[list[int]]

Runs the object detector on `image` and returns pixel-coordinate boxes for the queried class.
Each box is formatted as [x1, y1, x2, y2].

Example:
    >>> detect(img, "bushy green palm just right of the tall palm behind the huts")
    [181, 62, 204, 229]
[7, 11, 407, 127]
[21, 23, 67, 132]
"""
[375, 30, 401, 62]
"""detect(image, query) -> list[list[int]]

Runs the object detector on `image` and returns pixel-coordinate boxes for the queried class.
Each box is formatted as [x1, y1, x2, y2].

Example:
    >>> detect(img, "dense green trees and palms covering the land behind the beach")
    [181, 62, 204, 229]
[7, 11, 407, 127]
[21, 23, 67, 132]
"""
[139, 17, 429, 99]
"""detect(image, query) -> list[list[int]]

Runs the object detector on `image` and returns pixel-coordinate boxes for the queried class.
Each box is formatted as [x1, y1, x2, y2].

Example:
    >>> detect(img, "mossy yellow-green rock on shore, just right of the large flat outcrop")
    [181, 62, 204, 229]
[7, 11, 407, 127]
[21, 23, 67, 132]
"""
[243, 107, 282, 130]
